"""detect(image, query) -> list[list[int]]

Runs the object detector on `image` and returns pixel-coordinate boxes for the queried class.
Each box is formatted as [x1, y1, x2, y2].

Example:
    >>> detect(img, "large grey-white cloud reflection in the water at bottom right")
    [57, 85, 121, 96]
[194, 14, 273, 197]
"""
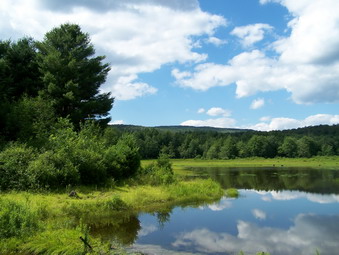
[172, 214, 339, 255]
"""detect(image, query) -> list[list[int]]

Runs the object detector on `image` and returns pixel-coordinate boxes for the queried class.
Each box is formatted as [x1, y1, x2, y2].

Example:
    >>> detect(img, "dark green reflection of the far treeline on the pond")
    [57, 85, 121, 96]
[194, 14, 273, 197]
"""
[195, 167, 339, 194]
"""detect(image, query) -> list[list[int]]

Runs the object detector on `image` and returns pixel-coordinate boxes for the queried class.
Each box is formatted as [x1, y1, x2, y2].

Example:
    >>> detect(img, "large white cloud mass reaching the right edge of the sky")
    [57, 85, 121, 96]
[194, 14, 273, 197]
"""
[177, 0, 339, 104]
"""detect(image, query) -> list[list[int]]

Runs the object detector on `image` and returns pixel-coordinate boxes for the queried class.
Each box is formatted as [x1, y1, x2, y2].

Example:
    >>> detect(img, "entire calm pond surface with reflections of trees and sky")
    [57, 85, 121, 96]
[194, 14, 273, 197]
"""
[96, 168, 339, 255]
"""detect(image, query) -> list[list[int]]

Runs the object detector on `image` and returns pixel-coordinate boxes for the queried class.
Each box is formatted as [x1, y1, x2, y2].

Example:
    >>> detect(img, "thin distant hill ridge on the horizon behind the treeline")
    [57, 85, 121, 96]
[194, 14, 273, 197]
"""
[112, 124, 253, 133]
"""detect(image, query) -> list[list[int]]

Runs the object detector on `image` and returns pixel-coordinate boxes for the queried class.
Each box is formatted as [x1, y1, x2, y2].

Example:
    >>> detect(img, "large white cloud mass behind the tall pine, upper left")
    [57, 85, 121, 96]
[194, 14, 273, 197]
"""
[0, 0, 226, 100]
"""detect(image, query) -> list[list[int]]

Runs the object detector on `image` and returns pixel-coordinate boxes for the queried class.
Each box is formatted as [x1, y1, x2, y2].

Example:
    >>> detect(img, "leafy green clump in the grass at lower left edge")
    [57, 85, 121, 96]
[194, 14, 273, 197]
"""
[0, 199, 39, 239]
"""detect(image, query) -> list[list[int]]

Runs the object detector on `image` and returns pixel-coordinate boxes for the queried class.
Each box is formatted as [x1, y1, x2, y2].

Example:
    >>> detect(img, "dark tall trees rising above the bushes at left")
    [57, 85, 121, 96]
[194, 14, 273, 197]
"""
[0, 24, 114, 142]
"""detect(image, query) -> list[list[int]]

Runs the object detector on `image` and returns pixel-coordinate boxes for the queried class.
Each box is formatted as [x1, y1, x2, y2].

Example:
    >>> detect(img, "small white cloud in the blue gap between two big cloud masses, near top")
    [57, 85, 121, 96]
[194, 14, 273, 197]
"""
[231, 23, 273, 47]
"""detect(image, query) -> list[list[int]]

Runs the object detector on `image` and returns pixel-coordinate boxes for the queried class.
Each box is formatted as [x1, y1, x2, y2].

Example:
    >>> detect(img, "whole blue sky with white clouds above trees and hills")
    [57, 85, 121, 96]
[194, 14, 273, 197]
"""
[0, 0, 339, 131]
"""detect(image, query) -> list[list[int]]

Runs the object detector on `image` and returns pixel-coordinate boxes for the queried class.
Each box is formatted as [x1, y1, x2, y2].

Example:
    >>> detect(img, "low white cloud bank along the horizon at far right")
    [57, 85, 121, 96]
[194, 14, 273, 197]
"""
[247, 114, 339, 131]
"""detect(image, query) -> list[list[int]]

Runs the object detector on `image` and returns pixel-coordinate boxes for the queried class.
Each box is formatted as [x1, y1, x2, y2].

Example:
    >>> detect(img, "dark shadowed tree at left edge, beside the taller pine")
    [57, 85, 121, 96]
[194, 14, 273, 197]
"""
[0, 38, 42, 139]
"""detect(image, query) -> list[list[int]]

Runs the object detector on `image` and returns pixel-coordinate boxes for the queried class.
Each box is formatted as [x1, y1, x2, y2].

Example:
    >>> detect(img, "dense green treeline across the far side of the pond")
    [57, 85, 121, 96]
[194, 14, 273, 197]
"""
[112, 125, 339, 159]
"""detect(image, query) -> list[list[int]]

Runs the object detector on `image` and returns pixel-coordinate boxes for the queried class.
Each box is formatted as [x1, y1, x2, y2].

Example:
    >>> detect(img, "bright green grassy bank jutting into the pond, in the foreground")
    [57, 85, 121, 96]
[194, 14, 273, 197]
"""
[0, 180, 224, 255]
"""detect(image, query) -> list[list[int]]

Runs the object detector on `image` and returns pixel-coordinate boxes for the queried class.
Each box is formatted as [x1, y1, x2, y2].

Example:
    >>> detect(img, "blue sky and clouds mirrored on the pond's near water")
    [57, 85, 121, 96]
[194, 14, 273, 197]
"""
[136, 190, 339, 255]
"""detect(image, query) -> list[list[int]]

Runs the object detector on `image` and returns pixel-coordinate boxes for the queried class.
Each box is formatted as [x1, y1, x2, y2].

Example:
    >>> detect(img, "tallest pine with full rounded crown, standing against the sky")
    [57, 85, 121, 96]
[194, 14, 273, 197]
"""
[37, 24, 114, 127]
